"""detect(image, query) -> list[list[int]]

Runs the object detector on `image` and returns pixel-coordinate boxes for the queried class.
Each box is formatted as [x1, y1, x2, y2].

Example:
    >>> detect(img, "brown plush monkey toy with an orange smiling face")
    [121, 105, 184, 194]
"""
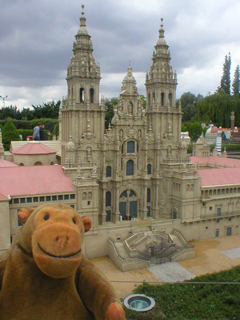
[0, 204, 125, 320]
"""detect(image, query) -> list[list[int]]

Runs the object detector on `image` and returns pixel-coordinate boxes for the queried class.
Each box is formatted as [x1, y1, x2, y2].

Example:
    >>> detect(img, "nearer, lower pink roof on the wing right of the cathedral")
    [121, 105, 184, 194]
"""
[198, 168, 240, 187]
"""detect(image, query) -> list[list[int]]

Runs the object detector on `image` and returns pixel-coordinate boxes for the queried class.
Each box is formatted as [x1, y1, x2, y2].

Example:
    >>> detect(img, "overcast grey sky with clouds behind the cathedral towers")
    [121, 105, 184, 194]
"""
[0, 0, 240, 109]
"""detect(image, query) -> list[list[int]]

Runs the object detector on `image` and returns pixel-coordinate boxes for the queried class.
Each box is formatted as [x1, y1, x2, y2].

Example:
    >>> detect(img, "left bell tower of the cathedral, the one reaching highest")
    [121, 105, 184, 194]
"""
[61, 5, 104, 164]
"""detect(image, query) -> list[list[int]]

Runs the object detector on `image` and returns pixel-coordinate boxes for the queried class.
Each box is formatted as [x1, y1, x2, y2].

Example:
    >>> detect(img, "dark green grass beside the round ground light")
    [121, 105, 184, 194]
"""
[125, 266, 240, 320]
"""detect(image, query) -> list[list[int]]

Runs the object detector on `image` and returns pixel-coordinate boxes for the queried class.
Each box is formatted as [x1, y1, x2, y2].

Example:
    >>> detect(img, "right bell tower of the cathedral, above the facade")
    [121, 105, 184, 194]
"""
[145, 19, 182, 152]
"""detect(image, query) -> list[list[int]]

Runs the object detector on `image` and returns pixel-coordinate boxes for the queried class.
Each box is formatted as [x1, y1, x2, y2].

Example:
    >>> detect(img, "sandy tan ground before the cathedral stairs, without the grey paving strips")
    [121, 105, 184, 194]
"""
[91, 235, 240, 298]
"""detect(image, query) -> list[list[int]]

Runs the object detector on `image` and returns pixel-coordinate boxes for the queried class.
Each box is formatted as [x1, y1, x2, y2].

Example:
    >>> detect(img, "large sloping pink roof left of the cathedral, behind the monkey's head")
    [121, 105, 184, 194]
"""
[0, 165, 74, 196]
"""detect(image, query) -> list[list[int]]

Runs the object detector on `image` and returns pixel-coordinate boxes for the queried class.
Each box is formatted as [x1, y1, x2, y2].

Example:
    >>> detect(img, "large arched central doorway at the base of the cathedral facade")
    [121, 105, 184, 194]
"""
[119, 190, 138, 220]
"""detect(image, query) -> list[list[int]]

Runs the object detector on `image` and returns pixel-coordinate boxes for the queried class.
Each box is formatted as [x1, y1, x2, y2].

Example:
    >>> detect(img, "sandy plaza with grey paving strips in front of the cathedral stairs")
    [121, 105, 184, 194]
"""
[91, 235, 240, 298]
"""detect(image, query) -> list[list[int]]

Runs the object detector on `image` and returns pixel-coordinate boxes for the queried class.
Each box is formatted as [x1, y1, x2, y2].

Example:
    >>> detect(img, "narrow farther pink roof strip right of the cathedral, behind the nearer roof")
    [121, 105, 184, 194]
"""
[191, 156, 240, 168]
